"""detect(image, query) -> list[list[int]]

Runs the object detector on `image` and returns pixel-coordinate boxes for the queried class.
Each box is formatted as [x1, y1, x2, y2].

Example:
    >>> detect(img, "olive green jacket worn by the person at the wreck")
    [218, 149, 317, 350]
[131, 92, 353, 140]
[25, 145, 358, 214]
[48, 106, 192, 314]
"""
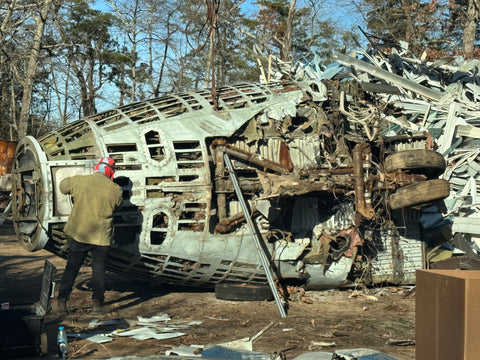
[60, 172, 122, 246]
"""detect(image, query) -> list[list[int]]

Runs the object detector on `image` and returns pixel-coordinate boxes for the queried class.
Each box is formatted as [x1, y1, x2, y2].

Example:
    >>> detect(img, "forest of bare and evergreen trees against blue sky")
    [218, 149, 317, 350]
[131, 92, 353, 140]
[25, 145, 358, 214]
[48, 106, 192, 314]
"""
[0, 0, 480, 141]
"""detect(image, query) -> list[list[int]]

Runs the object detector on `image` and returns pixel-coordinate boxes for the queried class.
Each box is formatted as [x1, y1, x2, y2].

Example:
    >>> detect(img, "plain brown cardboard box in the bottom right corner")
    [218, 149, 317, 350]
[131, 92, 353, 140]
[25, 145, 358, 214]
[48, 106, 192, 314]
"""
[415, 270, 480, 360]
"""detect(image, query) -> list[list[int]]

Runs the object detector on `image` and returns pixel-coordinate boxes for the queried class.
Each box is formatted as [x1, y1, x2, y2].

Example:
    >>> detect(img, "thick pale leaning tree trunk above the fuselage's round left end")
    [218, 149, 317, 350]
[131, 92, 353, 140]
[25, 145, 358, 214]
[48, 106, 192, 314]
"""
[17, 0, 52, 139]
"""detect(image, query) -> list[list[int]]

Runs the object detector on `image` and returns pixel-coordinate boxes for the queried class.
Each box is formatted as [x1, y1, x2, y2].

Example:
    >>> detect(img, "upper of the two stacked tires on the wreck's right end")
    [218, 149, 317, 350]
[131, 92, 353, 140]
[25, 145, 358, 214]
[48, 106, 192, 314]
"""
[385, 149, 446, 179]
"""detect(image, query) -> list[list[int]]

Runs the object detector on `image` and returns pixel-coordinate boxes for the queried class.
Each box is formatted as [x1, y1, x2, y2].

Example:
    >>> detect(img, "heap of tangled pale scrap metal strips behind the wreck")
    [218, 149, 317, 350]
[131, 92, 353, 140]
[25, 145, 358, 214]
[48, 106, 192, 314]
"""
[277, 44, 480, 259]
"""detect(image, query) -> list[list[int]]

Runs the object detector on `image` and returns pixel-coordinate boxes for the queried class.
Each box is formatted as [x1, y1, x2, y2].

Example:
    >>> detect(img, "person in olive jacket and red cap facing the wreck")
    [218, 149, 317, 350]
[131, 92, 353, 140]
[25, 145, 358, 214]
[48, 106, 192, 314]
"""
[58, 157, 122, 314]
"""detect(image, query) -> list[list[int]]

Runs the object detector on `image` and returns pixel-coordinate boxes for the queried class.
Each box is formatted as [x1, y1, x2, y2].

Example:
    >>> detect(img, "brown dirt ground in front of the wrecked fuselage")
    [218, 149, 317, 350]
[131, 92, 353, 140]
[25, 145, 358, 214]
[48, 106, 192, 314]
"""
[0, 221, 415, 360]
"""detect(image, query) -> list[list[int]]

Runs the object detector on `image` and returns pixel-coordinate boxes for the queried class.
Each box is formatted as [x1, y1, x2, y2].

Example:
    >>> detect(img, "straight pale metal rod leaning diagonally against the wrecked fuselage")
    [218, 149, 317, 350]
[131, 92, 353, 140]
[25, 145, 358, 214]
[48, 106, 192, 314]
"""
[223, 153, 287, 318]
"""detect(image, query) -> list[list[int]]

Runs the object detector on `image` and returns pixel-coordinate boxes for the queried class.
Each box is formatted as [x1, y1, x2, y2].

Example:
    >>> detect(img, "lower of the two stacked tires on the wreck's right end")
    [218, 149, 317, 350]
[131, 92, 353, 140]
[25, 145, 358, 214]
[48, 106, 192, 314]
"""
[389, 179, 450, 210]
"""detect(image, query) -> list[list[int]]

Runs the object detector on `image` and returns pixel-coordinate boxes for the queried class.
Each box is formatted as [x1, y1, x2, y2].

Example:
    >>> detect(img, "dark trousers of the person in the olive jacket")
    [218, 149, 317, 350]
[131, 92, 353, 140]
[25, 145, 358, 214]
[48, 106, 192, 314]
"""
[58, 238, 109, 303]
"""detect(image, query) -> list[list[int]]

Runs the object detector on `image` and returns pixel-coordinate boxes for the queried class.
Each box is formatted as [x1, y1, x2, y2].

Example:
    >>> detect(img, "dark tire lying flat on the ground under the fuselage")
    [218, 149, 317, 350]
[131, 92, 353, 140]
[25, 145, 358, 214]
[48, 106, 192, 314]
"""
[215, 283, 273, 301]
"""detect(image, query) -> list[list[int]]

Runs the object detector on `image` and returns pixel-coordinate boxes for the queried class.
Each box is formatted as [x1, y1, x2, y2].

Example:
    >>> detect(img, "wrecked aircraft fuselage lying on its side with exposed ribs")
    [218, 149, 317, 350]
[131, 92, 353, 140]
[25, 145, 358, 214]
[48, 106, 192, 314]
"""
[12, 52, 449, 296]
